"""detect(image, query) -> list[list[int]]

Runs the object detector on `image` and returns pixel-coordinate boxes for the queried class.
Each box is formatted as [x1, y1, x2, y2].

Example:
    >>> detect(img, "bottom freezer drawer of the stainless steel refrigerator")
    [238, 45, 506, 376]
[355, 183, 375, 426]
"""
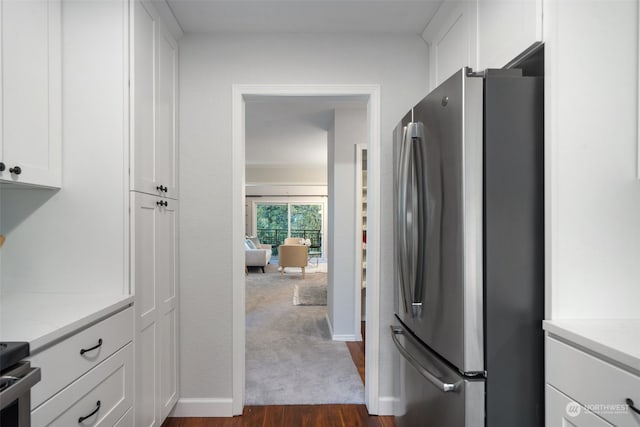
[391, 326, 485, 427]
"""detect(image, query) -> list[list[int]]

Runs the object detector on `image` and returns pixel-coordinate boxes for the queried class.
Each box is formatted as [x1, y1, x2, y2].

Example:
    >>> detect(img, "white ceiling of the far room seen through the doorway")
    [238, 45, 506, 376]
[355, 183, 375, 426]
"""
[245, 96, 367, 167]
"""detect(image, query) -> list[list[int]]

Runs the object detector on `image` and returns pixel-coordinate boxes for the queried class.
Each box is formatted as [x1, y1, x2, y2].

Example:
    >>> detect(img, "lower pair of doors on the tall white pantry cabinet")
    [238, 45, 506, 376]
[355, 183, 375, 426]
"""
[131, 192, 178, 427]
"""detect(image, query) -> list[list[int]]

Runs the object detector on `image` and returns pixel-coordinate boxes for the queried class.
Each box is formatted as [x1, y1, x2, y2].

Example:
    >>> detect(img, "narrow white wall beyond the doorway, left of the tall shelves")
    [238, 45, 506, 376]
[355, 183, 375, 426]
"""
[327, 108, 368, 341]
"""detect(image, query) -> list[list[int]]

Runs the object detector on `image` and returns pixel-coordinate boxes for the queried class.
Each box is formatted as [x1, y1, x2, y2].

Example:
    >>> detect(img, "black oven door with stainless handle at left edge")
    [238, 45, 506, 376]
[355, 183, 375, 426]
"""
[0, 362, 40, 427]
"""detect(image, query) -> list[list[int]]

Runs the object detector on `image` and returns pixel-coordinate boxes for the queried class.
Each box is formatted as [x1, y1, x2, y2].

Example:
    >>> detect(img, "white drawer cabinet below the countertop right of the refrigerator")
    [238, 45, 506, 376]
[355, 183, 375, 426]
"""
[545, 336, 640, 427]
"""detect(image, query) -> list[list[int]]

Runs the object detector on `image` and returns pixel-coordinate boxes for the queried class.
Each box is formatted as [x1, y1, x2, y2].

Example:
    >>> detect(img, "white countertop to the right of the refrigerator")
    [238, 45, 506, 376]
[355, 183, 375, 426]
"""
[542, 319, 640, 374]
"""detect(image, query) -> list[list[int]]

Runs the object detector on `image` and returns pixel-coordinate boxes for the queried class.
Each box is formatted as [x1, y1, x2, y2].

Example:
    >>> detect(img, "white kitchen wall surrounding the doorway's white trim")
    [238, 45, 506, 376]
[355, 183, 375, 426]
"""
[180, 34, 427, 404]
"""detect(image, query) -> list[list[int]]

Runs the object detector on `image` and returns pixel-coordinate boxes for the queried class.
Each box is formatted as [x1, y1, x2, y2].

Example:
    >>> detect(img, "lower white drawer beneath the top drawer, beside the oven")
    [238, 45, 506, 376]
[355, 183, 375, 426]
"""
[31, 344, 133, 427]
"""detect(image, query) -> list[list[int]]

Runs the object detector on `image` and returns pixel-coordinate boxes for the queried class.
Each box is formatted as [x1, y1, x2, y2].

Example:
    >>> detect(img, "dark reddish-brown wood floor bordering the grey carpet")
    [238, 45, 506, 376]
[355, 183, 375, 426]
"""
[162, 322, 394, 427]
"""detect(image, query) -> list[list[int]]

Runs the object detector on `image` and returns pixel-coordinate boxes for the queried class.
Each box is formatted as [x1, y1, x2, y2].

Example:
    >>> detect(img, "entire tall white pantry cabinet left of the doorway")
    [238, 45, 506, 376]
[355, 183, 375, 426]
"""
[130, 0, 178, 427]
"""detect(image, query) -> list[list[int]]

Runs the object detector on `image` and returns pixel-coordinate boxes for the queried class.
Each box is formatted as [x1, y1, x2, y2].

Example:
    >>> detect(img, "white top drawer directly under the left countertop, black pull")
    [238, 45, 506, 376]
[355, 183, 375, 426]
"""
[30, 308, 133, 409]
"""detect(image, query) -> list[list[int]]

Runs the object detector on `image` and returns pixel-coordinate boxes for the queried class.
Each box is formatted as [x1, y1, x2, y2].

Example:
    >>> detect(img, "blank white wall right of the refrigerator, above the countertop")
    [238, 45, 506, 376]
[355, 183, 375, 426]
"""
[544, 0, 640, 319]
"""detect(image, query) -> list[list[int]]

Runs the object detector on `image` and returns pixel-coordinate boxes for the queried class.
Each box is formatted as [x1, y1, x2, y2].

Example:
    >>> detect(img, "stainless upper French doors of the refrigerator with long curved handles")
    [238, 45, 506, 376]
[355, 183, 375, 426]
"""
[394, 69, 485, 373]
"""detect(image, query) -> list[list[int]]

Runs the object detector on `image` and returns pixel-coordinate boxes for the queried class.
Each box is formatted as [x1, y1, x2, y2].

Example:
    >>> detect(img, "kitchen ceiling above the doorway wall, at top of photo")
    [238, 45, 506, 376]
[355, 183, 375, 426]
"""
[167, 0, 442, 34]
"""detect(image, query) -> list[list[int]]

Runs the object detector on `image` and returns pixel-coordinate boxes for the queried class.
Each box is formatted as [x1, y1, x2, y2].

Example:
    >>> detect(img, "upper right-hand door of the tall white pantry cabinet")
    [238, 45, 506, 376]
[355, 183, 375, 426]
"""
[155, 24, 178, 199]
